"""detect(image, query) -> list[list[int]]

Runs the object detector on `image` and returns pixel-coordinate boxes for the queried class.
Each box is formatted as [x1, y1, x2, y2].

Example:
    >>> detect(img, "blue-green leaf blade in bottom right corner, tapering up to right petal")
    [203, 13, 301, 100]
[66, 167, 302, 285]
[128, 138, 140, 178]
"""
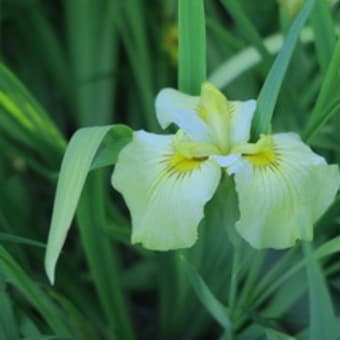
[303, 242, 337, 340]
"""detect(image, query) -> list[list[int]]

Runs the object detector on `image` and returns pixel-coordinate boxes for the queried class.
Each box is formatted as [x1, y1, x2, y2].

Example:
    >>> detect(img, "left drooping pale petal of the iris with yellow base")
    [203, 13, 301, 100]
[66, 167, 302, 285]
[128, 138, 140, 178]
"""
[112, 131, 221, 250]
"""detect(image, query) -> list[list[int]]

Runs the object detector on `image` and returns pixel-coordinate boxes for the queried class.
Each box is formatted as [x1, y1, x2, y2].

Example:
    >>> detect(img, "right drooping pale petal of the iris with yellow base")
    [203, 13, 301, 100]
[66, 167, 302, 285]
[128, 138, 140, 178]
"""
[228, 133, 340, 249]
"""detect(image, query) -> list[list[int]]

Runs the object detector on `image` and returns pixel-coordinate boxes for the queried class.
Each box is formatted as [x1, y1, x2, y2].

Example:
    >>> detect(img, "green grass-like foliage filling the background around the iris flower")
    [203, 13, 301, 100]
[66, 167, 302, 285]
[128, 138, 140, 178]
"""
[0, 0, 340, 340]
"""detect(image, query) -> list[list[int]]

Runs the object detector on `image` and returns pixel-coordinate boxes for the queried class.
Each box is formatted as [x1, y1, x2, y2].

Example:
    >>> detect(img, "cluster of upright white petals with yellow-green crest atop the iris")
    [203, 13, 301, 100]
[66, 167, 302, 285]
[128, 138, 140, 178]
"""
[156, 82, 256, 155]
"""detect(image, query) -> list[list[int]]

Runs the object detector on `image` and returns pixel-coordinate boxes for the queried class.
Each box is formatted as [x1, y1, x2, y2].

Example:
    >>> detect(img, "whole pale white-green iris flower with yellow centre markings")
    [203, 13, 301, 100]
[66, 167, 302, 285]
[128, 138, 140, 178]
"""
[112, 83, 340, 250]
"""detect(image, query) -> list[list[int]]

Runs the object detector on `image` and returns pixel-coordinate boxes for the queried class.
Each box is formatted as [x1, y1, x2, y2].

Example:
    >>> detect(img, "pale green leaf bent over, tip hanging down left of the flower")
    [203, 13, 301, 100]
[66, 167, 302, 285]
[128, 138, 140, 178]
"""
[45, 125, 131, 283]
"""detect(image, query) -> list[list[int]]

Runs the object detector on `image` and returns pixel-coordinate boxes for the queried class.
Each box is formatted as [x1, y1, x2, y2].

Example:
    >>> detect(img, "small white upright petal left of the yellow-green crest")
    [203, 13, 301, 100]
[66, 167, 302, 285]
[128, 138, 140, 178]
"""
[156, 88, 211, 142]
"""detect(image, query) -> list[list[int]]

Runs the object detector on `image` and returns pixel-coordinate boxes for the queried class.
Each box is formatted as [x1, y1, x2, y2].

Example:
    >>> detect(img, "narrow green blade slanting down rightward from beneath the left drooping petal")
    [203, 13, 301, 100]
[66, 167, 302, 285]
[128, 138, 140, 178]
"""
[181, 256, 231, 331]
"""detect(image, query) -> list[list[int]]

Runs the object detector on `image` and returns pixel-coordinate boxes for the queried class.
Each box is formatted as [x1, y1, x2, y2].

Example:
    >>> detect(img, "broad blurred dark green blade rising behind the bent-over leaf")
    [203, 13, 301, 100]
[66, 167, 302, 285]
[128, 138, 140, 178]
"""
[64, 0, 119, 126]
